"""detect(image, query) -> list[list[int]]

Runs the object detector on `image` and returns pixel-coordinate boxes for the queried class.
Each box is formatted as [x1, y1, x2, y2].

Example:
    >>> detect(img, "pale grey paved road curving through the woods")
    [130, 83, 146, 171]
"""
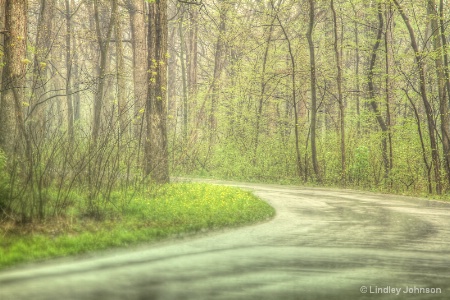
[0, 179, 450, 300]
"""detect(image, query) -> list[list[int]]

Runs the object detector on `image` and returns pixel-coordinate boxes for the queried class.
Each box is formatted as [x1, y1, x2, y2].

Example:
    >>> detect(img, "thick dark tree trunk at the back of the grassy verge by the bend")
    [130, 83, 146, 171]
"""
[145, 0, 169, 183]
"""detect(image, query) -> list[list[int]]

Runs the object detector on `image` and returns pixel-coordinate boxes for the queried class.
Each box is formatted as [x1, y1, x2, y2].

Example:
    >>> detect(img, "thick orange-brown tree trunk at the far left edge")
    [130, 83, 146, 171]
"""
[0, 0, 34, 222]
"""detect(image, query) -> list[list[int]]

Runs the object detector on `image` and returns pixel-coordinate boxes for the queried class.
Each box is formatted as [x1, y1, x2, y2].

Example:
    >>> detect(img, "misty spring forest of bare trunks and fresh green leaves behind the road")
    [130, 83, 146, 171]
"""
[0, 0, 450, 222]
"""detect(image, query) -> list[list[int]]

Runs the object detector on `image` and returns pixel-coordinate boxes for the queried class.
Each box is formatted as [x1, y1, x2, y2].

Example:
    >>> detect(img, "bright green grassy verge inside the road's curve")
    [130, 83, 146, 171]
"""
[0, 183, 275, 269]
